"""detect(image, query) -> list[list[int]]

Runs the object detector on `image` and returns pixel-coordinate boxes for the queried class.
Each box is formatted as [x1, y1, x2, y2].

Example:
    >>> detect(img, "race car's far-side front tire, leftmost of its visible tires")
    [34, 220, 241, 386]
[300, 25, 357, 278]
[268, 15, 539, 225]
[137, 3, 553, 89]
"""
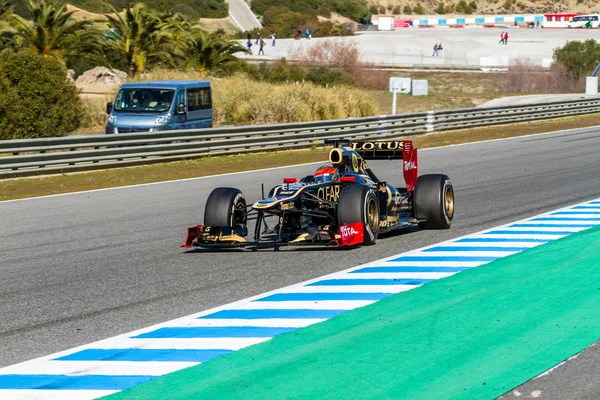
[204, 188, 247, 227]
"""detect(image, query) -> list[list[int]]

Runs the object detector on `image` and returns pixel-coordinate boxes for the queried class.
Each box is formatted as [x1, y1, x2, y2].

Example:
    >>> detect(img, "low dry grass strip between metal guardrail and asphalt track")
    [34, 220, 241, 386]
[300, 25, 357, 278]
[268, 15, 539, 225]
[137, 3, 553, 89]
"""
[5, 114, 600, 200]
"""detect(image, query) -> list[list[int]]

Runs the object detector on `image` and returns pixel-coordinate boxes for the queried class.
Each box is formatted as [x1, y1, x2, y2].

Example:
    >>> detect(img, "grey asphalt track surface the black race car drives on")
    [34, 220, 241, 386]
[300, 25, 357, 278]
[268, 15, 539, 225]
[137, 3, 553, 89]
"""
[0, 128, 600, 398]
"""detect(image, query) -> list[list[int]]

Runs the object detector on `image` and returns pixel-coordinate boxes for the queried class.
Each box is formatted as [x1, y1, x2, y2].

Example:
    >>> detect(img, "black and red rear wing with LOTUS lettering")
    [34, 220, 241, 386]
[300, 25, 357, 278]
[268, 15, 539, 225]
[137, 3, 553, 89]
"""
[325, 139, 418, 192]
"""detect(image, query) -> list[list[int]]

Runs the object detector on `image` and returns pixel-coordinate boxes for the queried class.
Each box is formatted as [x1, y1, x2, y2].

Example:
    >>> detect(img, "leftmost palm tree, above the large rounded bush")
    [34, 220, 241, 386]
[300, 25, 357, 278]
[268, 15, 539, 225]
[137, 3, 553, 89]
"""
[0, 0, 104, 64]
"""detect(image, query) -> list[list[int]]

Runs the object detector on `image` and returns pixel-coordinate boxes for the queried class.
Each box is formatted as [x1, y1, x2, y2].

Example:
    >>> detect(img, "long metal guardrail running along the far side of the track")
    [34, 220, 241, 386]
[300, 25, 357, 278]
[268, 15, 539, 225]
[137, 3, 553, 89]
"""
[0, 99, 600, 178]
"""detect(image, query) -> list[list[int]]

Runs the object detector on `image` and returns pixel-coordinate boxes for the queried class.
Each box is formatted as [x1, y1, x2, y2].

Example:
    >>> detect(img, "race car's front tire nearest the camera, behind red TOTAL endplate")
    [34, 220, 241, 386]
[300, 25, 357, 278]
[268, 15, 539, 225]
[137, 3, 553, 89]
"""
[337, 185, 379, 245]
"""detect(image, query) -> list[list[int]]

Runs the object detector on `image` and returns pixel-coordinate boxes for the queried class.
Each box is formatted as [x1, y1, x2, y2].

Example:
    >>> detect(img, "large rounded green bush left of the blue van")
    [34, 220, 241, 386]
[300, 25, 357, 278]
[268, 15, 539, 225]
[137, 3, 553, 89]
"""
[0, 51, 82, 140]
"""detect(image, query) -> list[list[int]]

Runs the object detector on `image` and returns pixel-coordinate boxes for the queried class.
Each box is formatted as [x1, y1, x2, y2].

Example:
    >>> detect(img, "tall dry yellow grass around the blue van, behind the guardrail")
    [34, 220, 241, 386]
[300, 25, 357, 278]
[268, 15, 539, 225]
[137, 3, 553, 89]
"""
[82, 70, 378, 129]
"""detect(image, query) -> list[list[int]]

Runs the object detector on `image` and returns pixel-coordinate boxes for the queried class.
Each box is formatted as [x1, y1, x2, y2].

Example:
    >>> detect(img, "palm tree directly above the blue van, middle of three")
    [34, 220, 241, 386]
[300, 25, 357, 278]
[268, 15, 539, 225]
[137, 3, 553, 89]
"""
[104, 3, 190, 76]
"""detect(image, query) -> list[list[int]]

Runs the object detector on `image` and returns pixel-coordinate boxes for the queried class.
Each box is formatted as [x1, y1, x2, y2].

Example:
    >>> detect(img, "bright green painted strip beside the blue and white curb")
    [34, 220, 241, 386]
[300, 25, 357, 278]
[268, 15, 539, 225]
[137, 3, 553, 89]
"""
[111, 228, 600, 400]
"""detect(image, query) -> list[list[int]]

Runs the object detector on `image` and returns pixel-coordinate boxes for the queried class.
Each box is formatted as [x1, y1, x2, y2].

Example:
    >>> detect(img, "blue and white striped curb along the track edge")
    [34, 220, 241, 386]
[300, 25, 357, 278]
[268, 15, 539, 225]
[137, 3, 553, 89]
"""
[0, 199, 600, 400]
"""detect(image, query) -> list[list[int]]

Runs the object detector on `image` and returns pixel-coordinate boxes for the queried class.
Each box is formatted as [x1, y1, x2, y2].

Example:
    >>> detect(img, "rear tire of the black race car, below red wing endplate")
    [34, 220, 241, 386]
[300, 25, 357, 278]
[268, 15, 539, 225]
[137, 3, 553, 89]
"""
[413, 174, 454, 229]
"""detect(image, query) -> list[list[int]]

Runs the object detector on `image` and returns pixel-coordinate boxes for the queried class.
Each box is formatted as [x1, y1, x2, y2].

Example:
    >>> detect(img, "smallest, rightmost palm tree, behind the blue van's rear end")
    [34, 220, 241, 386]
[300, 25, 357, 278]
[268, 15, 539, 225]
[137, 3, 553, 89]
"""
[185, 30, 251, 72]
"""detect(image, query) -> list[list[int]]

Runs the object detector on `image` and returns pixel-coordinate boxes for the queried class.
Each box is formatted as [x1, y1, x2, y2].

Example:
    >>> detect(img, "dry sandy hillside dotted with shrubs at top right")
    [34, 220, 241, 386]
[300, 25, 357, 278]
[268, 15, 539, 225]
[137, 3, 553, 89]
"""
[367, 0, 600, 15]
